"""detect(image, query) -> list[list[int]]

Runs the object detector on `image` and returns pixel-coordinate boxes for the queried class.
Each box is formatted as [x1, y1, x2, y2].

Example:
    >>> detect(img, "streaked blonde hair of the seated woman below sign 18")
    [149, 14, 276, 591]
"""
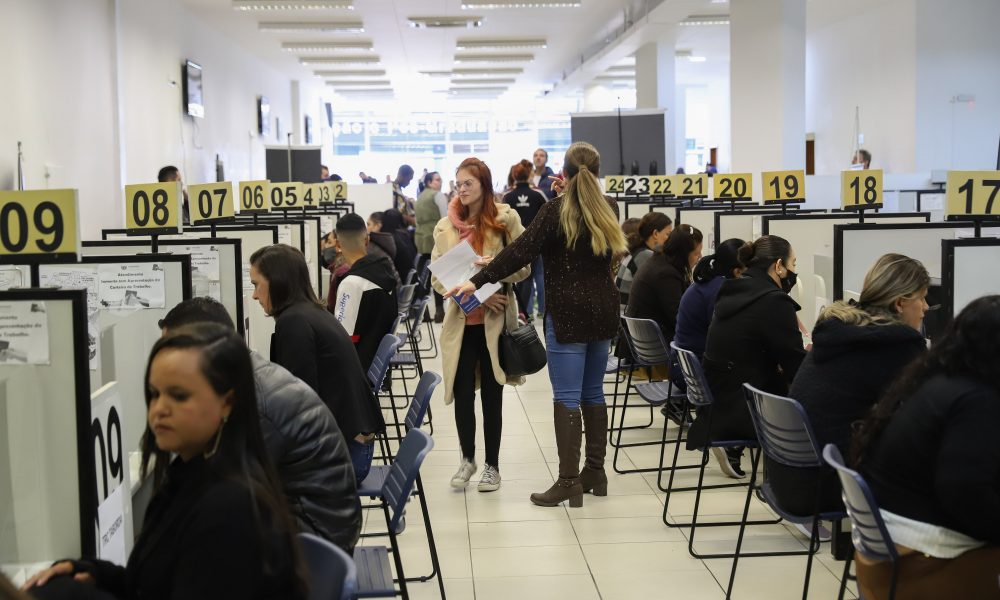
[819, 253, 931, 327]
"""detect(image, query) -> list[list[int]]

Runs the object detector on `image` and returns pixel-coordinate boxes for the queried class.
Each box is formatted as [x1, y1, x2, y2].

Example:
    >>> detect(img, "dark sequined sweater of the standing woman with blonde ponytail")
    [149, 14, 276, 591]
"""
[472, 196, 620, 344]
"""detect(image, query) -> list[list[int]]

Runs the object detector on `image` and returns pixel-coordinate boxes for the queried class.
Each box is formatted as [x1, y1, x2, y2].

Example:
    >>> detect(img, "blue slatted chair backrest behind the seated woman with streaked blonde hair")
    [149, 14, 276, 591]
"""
[743, 383, 824, 468]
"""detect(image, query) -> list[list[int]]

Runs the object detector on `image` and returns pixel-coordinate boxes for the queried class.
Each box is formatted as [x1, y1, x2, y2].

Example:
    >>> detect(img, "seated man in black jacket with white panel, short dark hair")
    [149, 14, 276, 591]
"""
[333, 213, 399, 371]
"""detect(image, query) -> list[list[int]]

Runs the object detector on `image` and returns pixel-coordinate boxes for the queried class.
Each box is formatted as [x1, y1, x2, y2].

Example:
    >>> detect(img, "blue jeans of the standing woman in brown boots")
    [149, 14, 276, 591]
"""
[545, 315, 611, 410]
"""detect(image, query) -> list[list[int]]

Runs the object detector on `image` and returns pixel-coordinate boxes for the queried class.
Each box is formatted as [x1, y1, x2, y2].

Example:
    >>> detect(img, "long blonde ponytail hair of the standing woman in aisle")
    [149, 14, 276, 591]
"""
[559, 142, 628, 256]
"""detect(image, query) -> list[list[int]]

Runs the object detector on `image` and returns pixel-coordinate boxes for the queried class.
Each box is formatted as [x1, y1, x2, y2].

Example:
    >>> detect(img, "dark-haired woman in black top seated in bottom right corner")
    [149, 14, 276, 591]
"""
[852, 296, 1000, 600]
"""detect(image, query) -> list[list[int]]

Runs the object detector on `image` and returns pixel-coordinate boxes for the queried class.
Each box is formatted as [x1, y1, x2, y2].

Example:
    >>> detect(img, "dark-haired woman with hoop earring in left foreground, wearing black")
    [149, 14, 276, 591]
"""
[25, 323, 306, 600]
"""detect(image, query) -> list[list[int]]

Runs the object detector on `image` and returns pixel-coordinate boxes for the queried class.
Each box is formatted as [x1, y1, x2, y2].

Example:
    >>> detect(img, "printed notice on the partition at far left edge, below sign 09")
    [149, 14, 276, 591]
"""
[0, 300, 49, 365]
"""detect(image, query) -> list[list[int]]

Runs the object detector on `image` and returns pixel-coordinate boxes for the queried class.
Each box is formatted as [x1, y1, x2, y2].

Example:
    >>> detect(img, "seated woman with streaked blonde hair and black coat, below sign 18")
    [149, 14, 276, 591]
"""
[764, 254, 930, 515]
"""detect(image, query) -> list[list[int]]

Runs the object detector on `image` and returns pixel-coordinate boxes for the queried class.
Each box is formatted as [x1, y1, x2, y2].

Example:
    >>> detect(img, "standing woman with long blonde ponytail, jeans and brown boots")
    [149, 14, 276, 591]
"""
[448, 142, 627, 507]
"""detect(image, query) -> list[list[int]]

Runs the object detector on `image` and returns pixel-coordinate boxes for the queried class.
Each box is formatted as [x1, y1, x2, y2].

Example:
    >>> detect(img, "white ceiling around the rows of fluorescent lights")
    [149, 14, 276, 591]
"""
[183, 0, 729, 99]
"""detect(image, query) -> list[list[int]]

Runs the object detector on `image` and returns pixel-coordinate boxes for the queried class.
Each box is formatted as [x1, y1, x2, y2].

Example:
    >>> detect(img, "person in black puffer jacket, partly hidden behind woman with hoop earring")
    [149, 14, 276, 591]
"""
[160, 298, 361, 554]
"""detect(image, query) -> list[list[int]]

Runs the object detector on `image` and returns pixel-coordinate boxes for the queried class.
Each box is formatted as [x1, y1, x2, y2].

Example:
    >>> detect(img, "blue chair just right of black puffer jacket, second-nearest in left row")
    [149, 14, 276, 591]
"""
[354, 429, 434, 599]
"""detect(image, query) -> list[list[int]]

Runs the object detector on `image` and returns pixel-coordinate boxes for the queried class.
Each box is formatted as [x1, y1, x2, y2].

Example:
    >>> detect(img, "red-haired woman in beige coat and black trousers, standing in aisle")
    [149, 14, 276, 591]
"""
[431, 158, 531, 492]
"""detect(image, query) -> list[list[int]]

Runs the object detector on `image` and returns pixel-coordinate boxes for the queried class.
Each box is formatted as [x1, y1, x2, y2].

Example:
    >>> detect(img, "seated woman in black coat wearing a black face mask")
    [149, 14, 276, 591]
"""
[688, 235, 805, 478]
